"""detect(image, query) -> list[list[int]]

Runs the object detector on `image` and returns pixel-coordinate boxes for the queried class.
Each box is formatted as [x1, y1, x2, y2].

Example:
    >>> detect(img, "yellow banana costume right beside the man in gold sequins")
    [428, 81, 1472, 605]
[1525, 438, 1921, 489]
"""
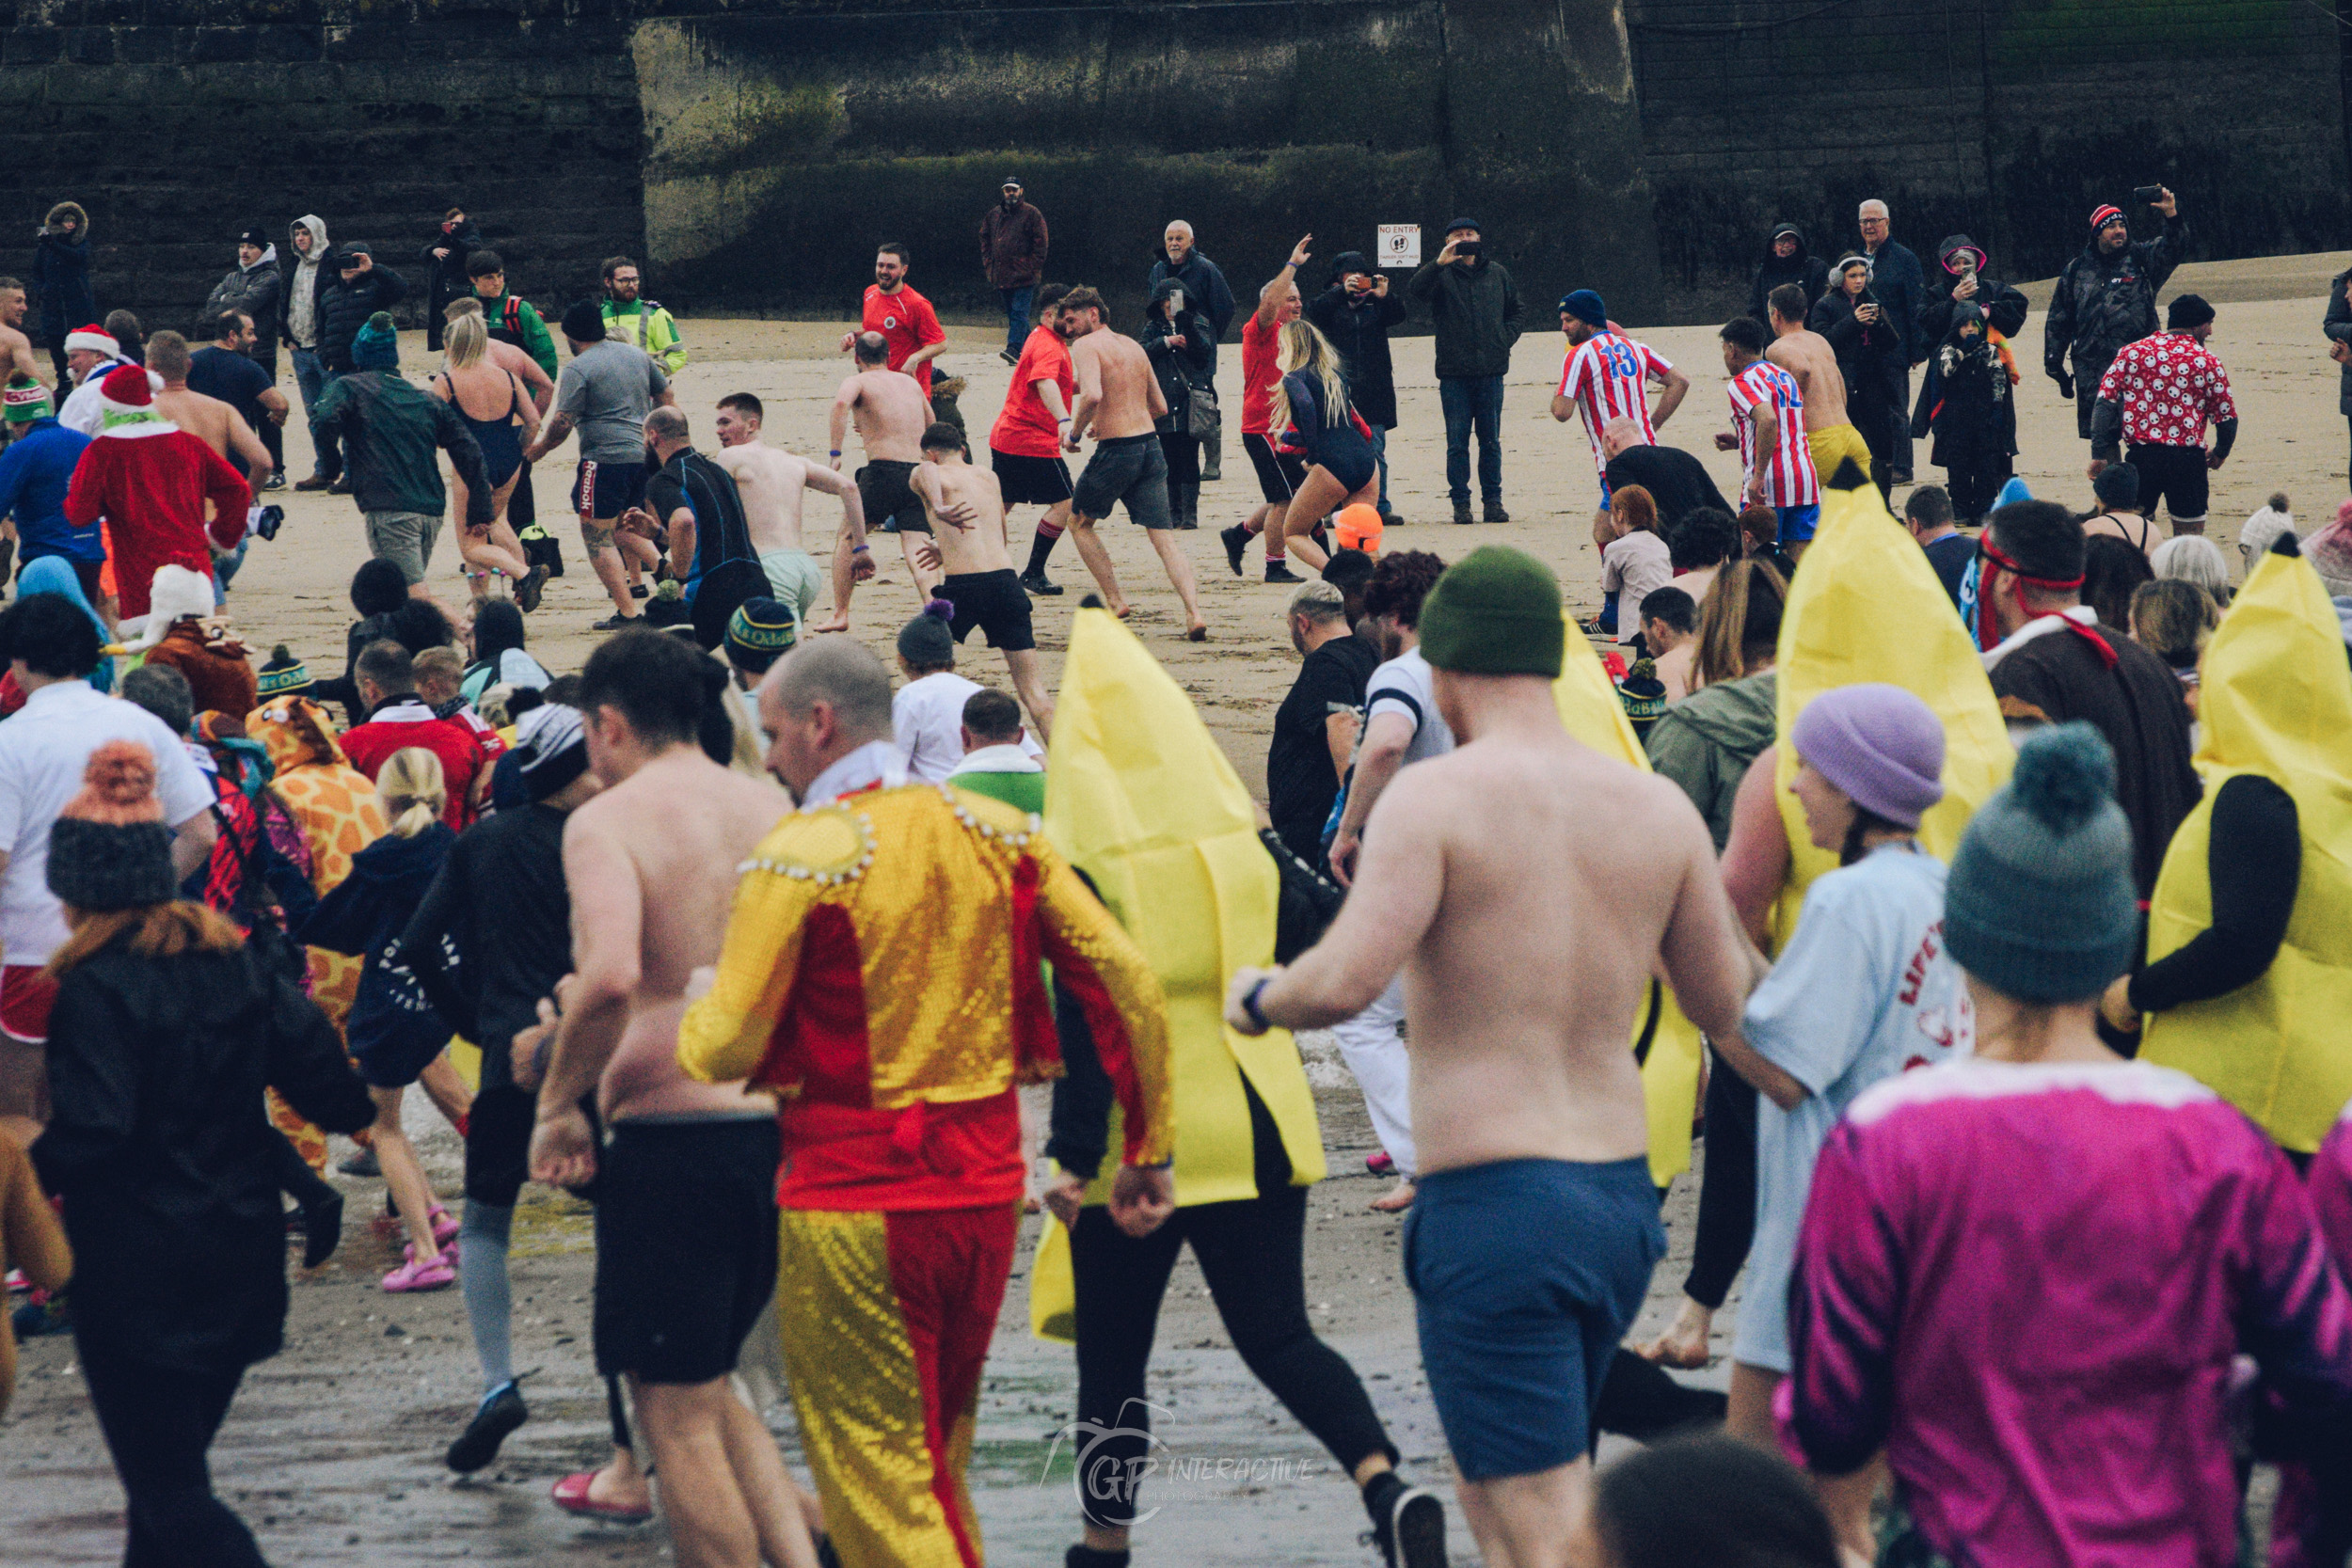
[1030, 609, 1325, 1338]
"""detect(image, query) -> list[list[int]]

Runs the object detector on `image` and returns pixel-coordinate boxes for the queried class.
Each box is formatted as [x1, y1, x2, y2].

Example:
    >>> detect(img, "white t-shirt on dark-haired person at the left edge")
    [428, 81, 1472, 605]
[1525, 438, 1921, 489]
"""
[0, 682, 212, 966]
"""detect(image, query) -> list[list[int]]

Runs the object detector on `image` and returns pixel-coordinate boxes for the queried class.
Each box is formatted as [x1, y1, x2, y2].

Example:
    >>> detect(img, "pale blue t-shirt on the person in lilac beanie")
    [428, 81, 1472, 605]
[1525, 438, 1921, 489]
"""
[1731, 844, 1976, 1373]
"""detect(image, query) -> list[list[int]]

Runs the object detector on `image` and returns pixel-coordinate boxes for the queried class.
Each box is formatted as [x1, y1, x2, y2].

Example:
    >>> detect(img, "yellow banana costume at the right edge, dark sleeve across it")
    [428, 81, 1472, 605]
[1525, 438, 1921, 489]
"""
[2140, 555, 2352, 1154]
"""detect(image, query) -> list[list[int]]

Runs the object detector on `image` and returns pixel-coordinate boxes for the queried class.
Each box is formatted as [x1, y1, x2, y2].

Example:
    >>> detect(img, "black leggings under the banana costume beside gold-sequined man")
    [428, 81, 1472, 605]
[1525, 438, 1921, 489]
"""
[1071, 1093, 1397, 1530]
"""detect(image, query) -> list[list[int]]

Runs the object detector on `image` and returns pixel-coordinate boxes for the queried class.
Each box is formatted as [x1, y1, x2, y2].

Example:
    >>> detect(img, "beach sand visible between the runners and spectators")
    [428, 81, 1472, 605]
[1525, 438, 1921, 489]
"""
[0, 254, 2324, 1566]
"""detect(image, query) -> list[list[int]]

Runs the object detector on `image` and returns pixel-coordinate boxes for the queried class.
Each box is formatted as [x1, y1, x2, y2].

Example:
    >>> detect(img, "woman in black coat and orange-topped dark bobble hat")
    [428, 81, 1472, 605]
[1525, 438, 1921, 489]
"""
[33, 740, 374, 1568]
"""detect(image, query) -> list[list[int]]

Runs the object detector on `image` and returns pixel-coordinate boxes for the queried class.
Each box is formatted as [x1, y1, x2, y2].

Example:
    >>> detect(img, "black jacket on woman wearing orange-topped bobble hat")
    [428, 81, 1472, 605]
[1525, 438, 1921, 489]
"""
[33, 938, 376, 1373]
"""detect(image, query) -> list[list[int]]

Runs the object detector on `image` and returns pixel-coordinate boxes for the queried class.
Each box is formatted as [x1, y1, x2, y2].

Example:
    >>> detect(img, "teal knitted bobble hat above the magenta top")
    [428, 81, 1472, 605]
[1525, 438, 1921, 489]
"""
[1943, 721, 2140, 1002]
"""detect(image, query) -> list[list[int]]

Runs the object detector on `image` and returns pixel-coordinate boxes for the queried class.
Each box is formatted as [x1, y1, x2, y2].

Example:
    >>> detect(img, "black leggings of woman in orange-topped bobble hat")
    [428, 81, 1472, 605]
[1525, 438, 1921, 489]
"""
[78, 1340, 266, 1568]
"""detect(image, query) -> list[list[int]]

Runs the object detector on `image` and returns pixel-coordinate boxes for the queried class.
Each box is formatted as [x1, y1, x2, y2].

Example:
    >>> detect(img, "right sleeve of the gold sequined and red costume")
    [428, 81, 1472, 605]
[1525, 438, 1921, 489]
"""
[1030, 839, 1176, 1166]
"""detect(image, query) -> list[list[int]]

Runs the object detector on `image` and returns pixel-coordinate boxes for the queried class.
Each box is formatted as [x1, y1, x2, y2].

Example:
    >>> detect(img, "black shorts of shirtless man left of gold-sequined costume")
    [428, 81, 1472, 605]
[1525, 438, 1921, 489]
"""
[596, 1117, 781, 1383]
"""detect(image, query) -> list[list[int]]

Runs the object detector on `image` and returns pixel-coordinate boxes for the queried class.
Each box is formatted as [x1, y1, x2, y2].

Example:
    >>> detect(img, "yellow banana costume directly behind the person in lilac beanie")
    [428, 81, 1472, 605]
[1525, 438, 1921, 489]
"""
[1772, 472, 2016, 926]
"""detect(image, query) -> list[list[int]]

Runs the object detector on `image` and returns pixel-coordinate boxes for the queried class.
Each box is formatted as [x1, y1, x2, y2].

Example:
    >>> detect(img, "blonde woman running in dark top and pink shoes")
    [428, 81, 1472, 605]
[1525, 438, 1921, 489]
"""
[296, 745, 456, 1293]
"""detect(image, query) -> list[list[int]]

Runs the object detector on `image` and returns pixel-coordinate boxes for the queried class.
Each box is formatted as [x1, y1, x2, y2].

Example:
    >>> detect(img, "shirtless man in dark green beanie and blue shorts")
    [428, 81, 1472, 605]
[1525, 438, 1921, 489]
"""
[1226, 547, 1757, 1568]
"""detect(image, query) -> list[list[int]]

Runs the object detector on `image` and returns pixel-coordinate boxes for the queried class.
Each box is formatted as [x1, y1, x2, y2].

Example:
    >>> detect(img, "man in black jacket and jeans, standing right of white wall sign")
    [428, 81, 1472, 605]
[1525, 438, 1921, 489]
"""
[1405, 218, 1519, 522]
